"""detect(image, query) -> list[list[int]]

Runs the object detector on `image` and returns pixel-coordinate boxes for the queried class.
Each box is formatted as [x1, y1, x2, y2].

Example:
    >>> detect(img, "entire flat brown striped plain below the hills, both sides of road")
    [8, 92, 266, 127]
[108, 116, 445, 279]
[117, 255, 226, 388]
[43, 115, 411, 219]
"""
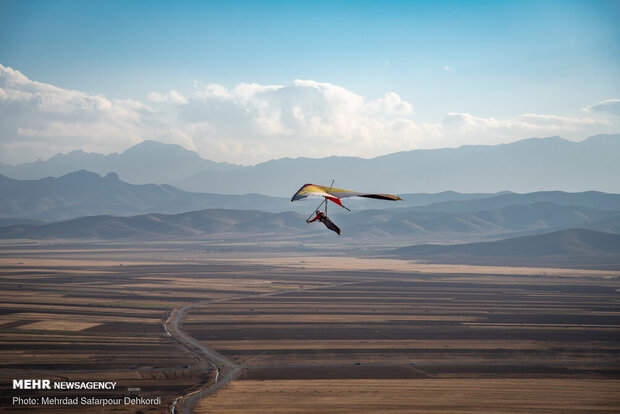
[0, 241, 620, 413]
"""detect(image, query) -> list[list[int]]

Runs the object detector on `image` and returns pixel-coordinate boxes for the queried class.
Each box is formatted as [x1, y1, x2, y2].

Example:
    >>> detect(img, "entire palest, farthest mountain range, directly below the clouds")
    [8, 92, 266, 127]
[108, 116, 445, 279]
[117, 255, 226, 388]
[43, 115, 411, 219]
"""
[0, 134, 620, 197]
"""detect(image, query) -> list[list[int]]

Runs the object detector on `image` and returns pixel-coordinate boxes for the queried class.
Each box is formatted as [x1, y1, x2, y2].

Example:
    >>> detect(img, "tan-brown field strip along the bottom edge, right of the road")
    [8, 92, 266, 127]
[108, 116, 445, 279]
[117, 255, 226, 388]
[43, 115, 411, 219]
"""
[198, 379, 618, 414]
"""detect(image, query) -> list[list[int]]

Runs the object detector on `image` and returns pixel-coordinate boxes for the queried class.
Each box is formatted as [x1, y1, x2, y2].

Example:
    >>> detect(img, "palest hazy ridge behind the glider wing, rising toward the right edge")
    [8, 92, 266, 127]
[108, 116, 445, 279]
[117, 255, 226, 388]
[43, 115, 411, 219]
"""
[174, 135, 620, 196]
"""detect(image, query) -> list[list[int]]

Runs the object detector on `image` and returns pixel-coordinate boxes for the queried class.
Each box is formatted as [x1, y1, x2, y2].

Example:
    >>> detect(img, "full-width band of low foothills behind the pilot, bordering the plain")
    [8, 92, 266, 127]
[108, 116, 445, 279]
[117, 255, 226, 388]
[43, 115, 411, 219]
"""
[0, 203, 620, 245]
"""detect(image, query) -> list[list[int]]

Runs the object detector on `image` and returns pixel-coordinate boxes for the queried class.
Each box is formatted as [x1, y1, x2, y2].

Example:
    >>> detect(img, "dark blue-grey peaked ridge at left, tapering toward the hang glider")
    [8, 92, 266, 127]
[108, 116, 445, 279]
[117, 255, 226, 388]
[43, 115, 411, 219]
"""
[0, 170, 290, 221]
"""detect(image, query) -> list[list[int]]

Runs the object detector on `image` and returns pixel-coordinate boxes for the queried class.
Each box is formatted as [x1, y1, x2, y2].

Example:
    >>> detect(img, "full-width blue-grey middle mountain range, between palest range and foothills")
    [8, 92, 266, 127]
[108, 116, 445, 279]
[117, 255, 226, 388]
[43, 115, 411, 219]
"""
[0, 170, 620, 231]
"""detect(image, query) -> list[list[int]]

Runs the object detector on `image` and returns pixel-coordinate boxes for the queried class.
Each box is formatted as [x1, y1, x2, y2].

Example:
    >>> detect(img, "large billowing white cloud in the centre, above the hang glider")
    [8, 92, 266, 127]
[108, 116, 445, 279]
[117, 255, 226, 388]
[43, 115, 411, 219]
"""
[147, 80, 426, 163]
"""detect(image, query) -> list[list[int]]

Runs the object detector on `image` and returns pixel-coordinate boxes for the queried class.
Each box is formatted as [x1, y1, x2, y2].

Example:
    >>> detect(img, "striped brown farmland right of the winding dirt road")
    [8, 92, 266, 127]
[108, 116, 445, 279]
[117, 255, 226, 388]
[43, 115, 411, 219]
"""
[184, 258, 620, 413]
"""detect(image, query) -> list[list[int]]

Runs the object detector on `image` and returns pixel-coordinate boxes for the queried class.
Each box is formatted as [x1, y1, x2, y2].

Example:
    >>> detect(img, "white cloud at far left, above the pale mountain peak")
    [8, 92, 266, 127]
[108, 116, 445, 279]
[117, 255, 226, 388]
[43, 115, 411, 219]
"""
[0, 65, 166, 163]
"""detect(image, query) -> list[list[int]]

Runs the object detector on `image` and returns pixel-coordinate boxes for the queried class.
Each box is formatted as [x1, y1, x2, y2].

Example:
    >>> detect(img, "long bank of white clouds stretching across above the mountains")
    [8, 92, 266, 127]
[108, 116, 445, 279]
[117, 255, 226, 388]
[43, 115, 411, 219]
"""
[0, 65, 620, 164]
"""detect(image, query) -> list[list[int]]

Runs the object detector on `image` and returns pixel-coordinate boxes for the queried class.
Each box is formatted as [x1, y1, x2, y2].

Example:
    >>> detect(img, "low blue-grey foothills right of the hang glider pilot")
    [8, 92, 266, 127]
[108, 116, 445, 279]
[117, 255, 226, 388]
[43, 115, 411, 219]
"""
[332, 202, 620, 243]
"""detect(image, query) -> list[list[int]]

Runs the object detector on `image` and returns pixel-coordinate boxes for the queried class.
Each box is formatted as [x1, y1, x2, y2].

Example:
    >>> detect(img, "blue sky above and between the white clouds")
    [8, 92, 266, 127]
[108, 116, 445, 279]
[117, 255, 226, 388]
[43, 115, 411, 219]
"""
[0, 0, 620, 163]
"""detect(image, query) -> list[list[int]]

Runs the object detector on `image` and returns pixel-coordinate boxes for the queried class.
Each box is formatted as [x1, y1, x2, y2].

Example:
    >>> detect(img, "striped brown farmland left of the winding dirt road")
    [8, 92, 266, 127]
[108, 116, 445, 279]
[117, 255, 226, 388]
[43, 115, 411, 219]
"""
[0, 243, 320, 413]
